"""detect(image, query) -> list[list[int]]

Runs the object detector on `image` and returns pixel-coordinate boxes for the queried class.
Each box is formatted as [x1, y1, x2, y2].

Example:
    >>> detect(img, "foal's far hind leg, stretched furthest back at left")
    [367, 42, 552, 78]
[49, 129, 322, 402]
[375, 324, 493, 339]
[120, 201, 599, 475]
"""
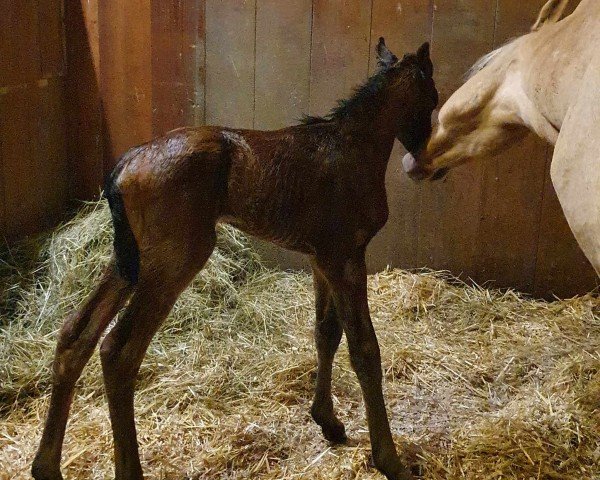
[31, 261, 132, 480]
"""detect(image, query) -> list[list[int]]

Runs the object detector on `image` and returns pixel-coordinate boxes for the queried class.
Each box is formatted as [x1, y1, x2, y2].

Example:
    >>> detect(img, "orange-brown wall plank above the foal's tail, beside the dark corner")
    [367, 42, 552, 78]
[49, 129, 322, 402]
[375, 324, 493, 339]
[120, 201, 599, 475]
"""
[98, 0, 152, 172]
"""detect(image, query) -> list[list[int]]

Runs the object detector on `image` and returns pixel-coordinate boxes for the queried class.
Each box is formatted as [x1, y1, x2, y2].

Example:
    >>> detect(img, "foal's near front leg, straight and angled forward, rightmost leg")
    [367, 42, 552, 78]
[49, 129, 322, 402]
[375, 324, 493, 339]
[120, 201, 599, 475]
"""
[316, 250, 412, 480]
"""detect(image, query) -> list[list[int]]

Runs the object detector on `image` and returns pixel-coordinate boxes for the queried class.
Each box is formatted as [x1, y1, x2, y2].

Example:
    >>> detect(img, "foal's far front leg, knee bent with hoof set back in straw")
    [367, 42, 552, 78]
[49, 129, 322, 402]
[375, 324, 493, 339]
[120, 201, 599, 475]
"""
[311, 262, 346, 443]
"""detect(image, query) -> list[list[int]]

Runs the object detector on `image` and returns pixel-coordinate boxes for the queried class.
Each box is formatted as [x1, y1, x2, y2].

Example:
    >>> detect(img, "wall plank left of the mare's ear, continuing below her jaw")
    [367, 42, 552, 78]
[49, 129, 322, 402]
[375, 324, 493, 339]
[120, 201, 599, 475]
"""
[473, 0, 546, 292]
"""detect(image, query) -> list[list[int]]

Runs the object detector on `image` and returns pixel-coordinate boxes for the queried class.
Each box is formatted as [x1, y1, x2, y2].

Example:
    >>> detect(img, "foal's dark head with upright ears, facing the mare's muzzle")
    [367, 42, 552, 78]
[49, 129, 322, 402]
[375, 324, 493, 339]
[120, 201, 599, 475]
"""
[377, 37, 438, 157]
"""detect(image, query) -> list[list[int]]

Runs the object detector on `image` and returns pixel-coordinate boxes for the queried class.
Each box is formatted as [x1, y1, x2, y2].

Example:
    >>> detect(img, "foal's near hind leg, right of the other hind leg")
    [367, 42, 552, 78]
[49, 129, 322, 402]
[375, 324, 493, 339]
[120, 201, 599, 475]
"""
[100, 233, 215, 480]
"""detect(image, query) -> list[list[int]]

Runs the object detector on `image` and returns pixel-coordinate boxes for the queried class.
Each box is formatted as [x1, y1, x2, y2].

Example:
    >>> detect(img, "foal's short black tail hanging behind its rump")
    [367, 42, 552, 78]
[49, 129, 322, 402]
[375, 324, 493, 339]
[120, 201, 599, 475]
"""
[104, 161, 140, 285]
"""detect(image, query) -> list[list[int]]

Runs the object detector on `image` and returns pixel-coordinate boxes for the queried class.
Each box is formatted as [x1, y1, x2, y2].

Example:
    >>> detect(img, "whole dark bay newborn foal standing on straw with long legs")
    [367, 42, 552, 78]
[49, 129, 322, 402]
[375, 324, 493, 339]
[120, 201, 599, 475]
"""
[32, 39, 438, 480]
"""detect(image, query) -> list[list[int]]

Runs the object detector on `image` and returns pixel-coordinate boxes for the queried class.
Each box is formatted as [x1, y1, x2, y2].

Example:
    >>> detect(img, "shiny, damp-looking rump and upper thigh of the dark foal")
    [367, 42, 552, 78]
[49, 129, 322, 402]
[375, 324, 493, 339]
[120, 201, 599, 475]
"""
[112, 127, 228, 266]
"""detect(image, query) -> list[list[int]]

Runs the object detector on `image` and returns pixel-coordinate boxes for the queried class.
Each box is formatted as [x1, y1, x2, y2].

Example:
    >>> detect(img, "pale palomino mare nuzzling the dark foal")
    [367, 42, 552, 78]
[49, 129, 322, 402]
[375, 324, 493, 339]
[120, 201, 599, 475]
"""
[403, 0, 600, 275]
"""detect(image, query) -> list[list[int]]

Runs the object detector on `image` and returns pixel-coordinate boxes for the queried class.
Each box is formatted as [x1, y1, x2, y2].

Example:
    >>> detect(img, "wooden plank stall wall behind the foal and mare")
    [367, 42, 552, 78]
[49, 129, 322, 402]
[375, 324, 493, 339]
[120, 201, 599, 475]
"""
[0, 0, 596, 296]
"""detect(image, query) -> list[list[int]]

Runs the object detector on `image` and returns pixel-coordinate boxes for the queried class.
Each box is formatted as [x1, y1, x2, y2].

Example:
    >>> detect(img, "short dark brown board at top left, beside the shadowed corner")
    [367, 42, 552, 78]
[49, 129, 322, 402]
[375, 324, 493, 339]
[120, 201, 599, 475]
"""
[38, 0, 65, 78]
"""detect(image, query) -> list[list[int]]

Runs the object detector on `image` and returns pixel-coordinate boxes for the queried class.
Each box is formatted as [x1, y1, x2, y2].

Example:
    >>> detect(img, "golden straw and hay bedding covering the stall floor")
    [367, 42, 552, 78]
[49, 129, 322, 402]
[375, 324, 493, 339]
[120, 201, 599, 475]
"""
[0, 204, 600, 480]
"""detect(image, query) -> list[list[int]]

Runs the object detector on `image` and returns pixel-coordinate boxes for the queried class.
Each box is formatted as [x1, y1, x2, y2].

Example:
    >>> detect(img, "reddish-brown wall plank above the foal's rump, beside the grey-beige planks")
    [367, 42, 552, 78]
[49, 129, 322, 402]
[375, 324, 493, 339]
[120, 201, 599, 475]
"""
[152, 0, 204, 136]
